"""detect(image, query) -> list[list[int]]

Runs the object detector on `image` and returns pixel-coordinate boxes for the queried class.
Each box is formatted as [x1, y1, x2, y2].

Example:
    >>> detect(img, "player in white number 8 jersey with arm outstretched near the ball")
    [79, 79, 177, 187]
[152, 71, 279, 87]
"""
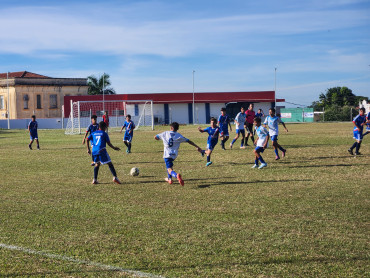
[154, 122, 203, 185]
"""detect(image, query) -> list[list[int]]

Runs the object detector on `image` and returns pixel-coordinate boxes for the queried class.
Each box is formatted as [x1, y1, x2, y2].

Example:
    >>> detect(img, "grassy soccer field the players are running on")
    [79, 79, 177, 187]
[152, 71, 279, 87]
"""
[0, 123, 370, 277]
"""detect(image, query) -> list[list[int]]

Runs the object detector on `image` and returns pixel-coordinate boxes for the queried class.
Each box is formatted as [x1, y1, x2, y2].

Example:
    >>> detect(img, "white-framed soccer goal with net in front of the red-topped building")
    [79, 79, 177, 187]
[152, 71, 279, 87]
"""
[65, 100, 154, 135]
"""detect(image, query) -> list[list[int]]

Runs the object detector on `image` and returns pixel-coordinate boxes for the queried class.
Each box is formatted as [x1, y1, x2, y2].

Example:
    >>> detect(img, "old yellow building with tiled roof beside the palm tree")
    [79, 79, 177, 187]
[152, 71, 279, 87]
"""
[0, 71, 88, 119]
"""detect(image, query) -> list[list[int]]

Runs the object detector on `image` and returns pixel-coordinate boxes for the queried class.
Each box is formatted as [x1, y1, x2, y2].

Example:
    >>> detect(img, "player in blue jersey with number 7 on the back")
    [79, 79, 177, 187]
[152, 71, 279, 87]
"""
[86, 121, 121, 184]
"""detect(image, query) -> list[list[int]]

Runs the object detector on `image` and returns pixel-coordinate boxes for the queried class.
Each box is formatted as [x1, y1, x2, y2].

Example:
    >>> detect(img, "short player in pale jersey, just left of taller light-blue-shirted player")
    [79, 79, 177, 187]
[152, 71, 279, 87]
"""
[252, 117, 270, 169]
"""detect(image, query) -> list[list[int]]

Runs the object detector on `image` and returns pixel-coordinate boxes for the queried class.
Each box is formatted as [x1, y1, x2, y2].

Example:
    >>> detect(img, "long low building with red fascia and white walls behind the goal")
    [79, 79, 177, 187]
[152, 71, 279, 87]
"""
[64, 91, 285, 124]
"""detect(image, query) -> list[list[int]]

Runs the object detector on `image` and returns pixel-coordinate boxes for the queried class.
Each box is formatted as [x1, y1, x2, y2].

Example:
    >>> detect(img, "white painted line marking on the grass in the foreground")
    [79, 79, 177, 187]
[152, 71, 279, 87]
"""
[0, 243, 164, 278]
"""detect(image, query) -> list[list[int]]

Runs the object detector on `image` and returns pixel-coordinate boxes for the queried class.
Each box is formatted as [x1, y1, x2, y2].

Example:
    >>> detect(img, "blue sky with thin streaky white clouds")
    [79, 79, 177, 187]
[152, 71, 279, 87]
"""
[0, 0, 370, 106]
